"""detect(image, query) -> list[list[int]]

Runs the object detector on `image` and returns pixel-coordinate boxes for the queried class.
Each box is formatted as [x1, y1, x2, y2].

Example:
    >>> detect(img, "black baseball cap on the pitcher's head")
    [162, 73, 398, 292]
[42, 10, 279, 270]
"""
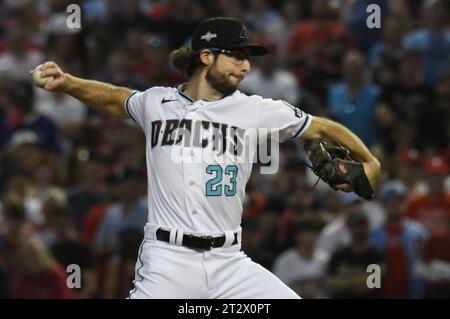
[191, 17, 268, 55]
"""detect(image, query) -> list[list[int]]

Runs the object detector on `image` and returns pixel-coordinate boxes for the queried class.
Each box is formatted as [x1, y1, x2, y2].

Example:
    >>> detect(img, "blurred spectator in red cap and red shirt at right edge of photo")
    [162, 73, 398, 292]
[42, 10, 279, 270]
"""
[406, 156, 450, 235]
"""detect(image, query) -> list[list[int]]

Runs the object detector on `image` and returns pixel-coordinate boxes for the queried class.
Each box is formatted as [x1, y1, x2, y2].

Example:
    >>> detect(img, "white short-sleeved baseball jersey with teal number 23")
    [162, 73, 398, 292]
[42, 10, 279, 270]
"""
[125, 86, 311, 235]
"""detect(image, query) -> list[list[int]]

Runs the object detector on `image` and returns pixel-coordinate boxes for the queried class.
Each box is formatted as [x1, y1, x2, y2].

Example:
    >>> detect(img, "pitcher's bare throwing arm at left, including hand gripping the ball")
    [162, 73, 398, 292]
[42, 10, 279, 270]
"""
[39, 61, 132, 118]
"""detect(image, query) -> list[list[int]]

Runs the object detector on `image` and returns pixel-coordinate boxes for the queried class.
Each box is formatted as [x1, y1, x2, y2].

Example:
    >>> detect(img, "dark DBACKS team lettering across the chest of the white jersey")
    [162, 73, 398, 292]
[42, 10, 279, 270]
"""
[151, 119, 245, 155]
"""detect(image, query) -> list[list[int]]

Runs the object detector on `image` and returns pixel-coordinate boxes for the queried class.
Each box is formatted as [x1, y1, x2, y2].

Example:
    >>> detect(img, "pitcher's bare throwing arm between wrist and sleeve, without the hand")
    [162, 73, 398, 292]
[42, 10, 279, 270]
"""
[63, 74, 132, 118]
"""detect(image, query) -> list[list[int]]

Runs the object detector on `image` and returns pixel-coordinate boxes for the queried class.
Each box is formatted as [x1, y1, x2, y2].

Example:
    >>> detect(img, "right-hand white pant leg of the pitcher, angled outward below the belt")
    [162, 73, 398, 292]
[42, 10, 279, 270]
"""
[208, 251, 301, 299]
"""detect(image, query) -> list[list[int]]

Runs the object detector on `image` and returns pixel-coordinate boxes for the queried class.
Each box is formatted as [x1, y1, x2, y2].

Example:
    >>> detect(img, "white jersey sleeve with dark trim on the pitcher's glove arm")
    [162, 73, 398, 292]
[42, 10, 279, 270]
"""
[258, 99, 312, 142]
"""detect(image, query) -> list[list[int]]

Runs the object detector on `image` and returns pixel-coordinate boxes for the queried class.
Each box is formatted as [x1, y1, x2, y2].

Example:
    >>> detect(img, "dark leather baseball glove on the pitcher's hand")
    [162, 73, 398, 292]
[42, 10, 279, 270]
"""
[305, 141, 373, 200]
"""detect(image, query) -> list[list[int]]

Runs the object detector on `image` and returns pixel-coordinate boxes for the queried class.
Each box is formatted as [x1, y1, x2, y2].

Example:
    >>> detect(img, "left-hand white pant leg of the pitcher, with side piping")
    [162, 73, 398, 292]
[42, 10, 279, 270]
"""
[129, 239, 206, 299]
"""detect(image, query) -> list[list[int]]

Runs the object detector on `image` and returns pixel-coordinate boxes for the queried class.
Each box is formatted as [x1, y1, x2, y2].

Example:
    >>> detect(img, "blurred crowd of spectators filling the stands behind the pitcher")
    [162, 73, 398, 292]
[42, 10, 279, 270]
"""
[0, 0, 450, 298]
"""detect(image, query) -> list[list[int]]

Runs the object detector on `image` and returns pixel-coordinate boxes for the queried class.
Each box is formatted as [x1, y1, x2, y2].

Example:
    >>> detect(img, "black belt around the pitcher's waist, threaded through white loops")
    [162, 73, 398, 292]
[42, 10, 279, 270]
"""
[156, 228, 238, 250]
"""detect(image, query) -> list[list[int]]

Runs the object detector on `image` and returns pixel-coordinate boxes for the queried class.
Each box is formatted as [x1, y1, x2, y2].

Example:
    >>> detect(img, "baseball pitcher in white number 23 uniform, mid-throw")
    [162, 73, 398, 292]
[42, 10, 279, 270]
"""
[32, 17, 380, 299]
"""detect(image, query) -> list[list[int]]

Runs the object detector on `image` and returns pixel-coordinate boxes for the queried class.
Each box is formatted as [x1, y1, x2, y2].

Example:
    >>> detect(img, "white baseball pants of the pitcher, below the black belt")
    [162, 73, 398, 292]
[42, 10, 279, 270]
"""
[129, 224, 300, 299]
